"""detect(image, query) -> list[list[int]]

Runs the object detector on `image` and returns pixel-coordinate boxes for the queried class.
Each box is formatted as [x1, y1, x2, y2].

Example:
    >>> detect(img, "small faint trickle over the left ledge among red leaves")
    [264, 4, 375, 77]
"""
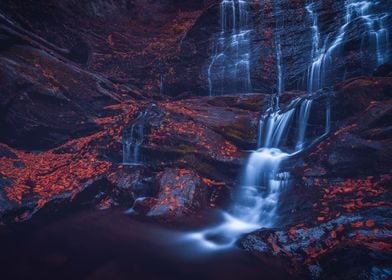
[123, 111, 147, 165]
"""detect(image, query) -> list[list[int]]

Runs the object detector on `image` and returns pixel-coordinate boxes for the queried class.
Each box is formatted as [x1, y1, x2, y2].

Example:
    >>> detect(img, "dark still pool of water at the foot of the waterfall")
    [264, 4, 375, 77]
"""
[0, 209, 292, 280]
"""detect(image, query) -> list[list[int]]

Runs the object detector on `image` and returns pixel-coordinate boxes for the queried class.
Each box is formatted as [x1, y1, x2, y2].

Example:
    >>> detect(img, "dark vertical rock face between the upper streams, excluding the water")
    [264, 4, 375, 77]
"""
[167, 0, 392, 94]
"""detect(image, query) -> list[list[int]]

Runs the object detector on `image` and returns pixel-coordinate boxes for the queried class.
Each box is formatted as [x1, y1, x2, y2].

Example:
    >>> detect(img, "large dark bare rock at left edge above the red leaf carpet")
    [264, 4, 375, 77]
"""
[0, 46, 122, 149]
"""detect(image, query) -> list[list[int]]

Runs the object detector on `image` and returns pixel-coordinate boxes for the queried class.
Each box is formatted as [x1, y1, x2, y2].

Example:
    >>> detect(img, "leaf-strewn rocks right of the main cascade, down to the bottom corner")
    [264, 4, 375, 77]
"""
[240, 77, 392, 279]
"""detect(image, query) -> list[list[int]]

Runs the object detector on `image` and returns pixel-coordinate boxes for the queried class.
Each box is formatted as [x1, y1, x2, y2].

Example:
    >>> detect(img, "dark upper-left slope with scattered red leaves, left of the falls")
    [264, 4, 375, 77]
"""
[0, 0, 211, 96]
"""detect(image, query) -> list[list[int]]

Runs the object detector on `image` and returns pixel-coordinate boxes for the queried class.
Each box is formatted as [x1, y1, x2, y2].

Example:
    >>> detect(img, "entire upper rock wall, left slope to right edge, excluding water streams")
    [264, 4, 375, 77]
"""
[0, 0, 392, 96]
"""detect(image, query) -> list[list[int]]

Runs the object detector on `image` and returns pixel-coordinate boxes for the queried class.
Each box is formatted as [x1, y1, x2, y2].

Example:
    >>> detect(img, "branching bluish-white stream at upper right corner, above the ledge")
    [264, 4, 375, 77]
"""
[306, 0, 389, 93]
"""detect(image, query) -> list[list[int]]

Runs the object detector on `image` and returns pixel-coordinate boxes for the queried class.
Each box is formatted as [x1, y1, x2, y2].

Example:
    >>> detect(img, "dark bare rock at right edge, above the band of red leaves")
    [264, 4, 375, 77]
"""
[305, 77, 392, 176]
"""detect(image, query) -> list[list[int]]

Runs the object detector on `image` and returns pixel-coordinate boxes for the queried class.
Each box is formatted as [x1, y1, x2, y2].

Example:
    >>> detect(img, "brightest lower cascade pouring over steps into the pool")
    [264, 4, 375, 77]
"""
[187, 96, 330, 250]
